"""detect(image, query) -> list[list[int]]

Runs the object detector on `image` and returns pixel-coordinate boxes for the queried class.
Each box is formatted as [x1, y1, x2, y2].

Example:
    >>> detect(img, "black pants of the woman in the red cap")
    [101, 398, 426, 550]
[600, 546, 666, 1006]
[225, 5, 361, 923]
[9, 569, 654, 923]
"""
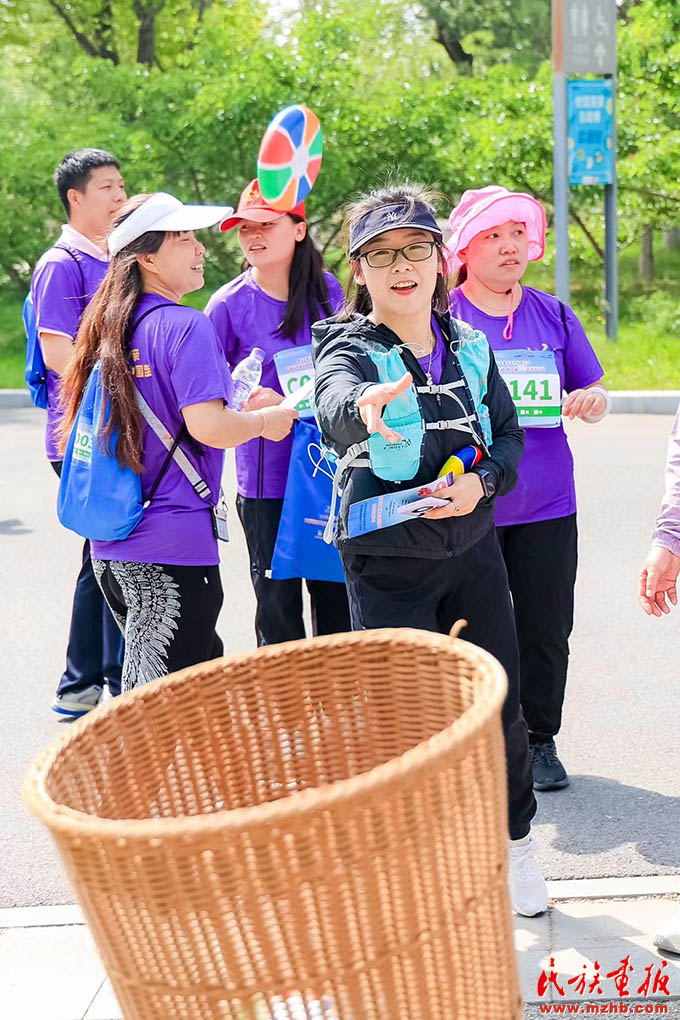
[237, 496, 352, 646]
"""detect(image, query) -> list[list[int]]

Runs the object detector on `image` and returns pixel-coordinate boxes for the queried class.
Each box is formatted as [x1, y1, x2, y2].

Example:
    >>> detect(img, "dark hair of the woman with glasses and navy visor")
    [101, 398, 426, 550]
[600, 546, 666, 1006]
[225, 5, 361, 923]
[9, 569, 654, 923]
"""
[341, 181, 449, 319]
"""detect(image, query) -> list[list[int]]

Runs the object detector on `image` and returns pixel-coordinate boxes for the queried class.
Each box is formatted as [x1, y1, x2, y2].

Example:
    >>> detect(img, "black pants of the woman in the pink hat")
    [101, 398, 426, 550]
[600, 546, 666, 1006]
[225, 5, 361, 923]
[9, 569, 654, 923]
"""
[498, 514, 578, 742]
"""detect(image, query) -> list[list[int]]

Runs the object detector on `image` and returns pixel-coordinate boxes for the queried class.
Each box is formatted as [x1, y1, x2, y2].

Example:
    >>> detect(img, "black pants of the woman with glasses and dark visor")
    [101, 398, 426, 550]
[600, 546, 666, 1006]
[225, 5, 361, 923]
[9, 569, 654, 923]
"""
[343, 530, 536, 839]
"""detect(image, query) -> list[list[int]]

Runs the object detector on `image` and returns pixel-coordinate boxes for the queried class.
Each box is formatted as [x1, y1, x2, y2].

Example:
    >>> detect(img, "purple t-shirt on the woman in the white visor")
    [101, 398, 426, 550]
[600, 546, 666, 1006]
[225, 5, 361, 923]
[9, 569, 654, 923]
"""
[92, 294, 231, 566]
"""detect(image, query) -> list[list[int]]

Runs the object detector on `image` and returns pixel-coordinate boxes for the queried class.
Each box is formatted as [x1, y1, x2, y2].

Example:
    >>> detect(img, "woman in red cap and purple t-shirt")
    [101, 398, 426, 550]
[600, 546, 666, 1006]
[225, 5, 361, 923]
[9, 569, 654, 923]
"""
[206, 181, 351, 645]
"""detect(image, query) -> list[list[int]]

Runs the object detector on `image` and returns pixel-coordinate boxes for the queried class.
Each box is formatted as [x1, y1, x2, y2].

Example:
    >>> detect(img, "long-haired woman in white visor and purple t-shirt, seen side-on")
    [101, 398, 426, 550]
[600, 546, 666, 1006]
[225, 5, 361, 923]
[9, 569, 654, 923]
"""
[61, 192, 297, 691]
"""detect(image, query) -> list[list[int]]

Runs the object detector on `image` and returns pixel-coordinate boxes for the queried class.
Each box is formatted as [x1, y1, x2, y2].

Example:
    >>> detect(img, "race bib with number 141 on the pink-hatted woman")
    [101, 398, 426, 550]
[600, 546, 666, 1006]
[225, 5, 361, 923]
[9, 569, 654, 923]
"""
[493, 350, 562, 428]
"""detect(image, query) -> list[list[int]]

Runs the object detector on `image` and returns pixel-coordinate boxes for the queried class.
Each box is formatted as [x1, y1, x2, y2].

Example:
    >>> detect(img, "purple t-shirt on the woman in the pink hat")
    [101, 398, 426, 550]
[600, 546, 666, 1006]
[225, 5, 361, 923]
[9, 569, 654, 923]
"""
[451, 287, 604, 525]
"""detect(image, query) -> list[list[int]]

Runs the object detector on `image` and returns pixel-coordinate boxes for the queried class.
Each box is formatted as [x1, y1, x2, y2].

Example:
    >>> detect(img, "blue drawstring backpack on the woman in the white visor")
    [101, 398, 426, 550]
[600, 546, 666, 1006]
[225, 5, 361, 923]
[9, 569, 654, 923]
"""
[57, 361, 144, 542]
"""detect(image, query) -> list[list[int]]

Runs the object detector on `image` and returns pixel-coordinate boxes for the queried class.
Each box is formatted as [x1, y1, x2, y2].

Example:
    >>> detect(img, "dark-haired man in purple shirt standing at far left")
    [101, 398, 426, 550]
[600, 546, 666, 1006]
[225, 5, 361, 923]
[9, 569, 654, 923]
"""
[31, 149, 126, 716]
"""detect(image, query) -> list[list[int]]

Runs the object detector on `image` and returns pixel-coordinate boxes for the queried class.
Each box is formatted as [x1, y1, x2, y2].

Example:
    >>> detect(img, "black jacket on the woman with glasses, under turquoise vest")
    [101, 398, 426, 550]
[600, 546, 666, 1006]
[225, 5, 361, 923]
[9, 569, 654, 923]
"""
[312, 314, 524, 559]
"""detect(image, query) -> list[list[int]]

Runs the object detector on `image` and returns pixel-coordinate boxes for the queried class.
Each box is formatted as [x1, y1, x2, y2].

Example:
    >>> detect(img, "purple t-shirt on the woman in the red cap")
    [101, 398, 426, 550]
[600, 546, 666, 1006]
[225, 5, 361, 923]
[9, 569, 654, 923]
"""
[206, 269, 343, 499]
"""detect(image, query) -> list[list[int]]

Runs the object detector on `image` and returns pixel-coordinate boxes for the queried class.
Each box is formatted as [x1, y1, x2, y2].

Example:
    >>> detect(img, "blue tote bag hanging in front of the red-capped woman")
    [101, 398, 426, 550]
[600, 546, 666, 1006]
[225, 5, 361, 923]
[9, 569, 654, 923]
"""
[271, 420, 345, 582]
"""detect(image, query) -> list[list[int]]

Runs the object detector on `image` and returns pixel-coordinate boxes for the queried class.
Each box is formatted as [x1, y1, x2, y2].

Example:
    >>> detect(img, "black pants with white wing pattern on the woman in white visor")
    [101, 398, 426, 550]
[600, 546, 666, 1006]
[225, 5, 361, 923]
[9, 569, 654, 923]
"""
[93, 560, 223, 692]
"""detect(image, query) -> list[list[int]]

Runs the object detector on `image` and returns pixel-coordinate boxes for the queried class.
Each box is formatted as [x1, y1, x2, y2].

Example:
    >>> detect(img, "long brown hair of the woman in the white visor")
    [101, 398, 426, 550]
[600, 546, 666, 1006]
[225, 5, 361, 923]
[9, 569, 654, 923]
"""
[58, 195, 165, 473]
